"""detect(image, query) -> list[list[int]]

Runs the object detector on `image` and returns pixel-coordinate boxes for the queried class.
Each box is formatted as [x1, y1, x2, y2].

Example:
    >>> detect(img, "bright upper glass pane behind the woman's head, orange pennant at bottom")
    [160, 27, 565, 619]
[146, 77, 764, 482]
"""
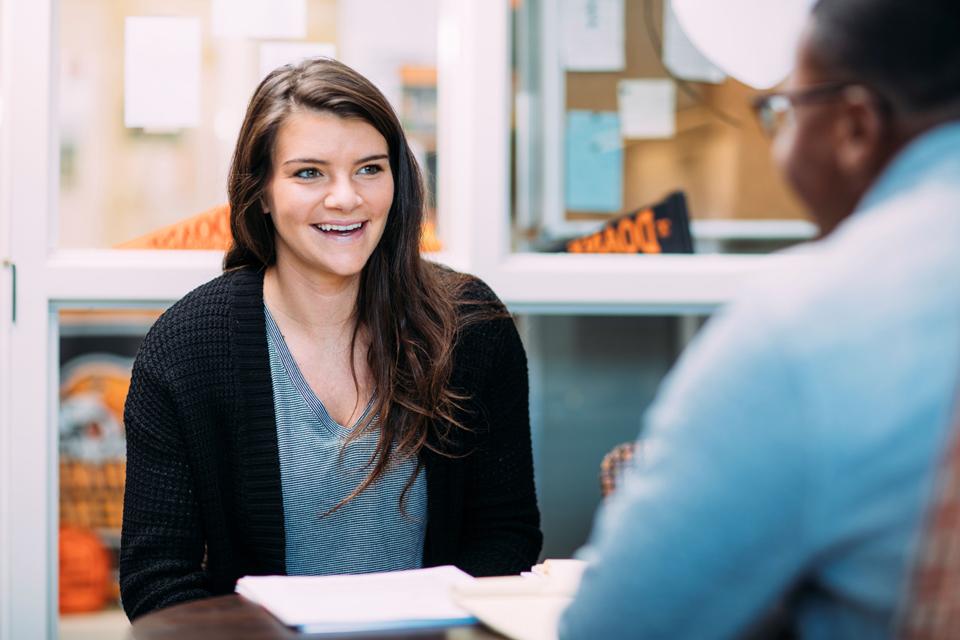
[58, 0, 438, 248]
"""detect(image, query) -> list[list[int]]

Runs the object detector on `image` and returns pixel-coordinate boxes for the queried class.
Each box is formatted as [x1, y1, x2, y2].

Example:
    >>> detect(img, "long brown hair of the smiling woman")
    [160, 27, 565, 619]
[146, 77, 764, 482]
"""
[223, 58, 496, 513]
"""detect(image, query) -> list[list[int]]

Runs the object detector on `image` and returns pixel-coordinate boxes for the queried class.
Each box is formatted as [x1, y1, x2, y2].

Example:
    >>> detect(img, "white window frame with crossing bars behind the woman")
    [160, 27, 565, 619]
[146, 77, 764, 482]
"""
[0, 0, 796, 640]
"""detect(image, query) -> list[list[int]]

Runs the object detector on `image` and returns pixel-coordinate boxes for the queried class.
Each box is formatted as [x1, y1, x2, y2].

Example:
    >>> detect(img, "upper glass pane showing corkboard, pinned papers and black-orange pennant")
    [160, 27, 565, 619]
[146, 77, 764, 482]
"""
[513, 0, 813, 253]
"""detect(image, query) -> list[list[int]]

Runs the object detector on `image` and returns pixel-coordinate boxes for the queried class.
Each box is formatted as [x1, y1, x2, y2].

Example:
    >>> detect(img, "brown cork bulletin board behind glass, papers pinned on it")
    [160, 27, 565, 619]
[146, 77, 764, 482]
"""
[565, 0, 804, 220]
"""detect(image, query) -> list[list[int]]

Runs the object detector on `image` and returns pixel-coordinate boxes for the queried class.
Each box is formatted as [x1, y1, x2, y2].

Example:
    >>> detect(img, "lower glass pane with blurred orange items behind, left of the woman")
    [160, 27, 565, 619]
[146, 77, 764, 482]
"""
[58, 309, 160, 640]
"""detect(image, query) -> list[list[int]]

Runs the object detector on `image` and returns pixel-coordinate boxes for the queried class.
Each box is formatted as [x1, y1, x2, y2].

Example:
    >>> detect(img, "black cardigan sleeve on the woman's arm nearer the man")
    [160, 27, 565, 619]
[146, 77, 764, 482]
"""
[456, 316, 543, 576]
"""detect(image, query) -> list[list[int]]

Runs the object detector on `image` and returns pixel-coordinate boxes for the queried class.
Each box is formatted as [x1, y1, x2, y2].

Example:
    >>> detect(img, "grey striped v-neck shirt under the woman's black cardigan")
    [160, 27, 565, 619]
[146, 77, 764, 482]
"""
[264, 306, 427, 575]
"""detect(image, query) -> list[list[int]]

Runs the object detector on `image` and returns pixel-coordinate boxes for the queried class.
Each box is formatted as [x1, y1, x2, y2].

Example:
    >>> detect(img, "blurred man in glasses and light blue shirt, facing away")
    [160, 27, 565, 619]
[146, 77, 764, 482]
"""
[561, 0, 960, 639]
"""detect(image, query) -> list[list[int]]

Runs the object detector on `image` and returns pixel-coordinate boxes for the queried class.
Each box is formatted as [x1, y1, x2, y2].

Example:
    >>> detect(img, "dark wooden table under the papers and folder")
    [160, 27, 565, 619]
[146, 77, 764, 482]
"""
[127, 595, 503, 640]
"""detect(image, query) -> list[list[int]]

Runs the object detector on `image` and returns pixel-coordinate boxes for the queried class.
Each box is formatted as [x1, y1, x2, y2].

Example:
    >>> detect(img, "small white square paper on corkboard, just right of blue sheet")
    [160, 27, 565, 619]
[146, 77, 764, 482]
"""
[617, 79, 677, 139]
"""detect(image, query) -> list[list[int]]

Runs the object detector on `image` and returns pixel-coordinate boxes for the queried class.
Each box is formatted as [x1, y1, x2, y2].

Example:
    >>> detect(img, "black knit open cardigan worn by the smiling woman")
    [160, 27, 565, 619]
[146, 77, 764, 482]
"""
[120, 270, 542, 619]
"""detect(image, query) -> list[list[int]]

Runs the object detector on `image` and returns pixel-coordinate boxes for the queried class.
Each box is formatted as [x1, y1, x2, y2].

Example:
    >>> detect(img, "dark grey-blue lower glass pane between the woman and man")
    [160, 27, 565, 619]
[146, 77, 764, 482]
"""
[520, 315, 703, 558]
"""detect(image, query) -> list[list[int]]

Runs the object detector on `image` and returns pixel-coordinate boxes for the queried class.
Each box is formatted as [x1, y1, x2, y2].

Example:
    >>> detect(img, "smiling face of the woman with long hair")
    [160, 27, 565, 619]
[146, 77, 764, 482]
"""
[264, 110, 393, 281]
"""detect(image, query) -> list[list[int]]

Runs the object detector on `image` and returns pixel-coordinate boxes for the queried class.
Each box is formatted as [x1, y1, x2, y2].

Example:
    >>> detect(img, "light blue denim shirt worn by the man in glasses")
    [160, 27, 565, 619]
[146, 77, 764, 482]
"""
[561, 123, 960, 640]
